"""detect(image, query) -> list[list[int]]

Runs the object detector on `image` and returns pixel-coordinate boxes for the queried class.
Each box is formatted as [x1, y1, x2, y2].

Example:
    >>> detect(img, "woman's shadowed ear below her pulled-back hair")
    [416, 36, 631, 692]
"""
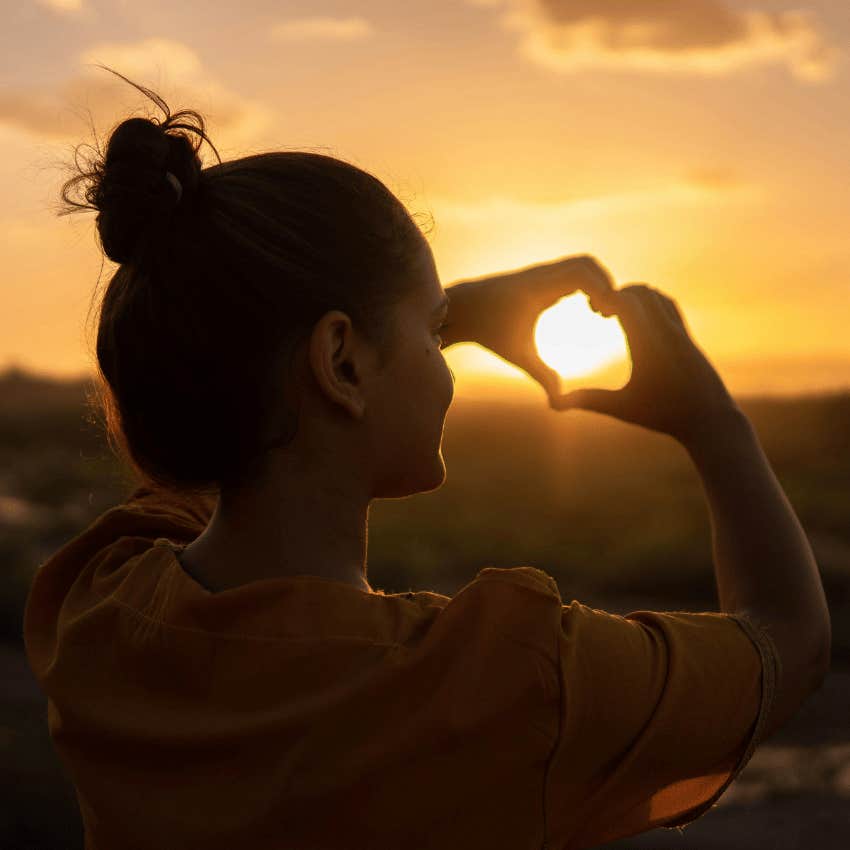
[309, 310, 367, 419]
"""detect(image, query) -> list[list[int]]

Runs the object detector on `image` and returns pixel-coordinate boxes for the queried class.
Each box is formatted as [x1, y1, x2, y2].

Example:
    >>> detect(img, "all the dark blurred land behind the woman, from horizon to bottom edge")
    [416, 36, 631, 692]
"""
[0, 369, 850, 850]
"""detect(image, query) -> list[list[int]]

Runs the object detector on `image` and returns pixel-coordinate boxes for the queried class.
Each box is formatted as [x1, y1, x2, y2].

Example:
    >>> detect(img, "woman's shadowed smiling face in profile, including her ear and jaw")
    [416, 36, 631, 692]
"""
[279, 232, 454, 502]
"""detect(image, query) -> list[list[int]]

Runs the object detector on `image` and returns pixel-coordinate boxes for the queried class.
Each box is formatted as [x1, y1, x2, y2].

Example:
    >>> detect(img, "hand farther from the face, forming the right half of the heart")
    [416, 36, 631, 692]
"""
[550, 284, 740, 445]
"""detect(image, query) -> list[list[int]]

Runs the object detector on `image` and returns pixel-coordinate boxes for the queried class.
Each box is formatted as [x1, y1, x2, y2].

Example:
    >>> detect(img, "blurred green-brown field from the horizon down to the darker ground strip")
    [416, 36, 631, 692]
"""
[0, 372, 850, 659]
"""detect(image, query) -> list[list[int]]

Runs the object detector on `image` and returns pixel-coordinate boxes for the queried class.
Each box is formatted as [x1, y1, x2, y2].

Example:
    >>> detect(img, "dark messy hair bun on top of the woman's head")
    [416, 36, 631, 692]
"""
[94, 118, 201, 263]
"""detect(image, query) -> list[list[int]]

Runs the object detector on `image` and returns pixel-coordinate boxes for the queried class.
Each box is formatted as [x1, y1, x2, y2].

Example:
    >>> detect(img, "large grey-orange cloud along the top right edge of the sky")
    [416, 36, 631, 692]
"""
[467, 0, 841, 82]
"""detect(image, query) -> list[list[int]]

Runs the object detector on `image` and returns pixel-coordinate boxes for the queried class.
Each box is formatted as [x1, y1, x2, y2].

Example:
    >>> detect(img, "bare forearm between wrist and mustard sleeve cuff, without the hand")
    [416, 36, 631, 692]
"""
[684, 408, 832, 737]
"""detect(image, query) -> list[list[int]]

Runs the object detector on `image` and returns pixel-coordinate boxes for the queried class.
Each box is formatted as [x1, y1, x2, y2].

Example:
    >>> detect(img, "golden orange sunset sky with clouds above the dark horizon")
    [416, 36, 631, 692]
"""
[0, 0, 850, 399]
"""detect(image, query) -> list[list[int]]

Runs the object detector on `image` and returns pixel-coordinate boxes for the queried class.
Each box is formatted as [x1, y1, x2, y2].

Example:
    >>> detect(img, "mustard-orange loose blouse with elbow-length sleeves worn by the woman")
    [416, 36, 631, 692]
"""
[24, 488, 781, 850]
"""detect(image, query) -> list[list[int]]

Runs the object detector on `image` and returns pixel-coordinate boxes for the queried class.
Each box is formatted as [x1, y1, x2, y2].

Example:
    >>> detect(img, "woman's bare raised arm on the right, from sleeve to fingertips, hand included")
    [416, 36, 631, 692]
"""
[561, 284, 832, 736]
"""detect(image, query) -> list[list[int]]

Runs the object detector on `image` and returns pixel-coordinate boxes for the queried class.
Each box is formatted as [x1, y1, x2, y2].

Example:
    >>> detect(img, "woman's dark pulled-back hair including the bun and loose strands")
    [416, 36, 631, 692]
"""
[60, 71, 424, 492]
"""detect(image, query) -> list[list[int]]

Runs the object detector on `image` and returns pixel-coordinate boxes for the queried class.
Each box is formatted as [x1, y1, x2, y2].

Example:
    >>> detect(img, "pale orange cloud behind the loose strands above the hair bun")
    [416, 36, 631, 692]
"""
[0, 38, 273, 143]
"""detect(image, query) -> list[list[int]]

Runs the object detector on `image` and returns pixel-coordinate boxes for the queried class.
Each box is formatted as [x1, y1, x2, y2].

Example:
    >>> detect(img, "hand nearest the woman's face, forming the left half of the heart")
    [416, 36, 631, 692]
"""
[447, 254, 614, 403]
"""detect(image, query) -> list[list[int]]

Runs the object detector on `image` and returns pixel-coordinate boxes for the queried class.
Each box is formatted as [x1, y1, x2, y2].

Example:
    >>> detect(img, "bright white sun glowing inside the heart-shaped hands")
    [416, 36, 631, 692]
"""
[534, 292, 628, 378]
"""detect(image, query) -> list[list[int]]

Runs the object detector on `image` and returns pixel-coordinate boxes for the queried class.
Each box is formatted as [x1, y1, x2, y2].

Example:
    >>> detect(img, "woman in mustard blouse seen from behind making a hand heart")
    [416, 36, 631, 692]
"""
[24, 73, 829, 850]
